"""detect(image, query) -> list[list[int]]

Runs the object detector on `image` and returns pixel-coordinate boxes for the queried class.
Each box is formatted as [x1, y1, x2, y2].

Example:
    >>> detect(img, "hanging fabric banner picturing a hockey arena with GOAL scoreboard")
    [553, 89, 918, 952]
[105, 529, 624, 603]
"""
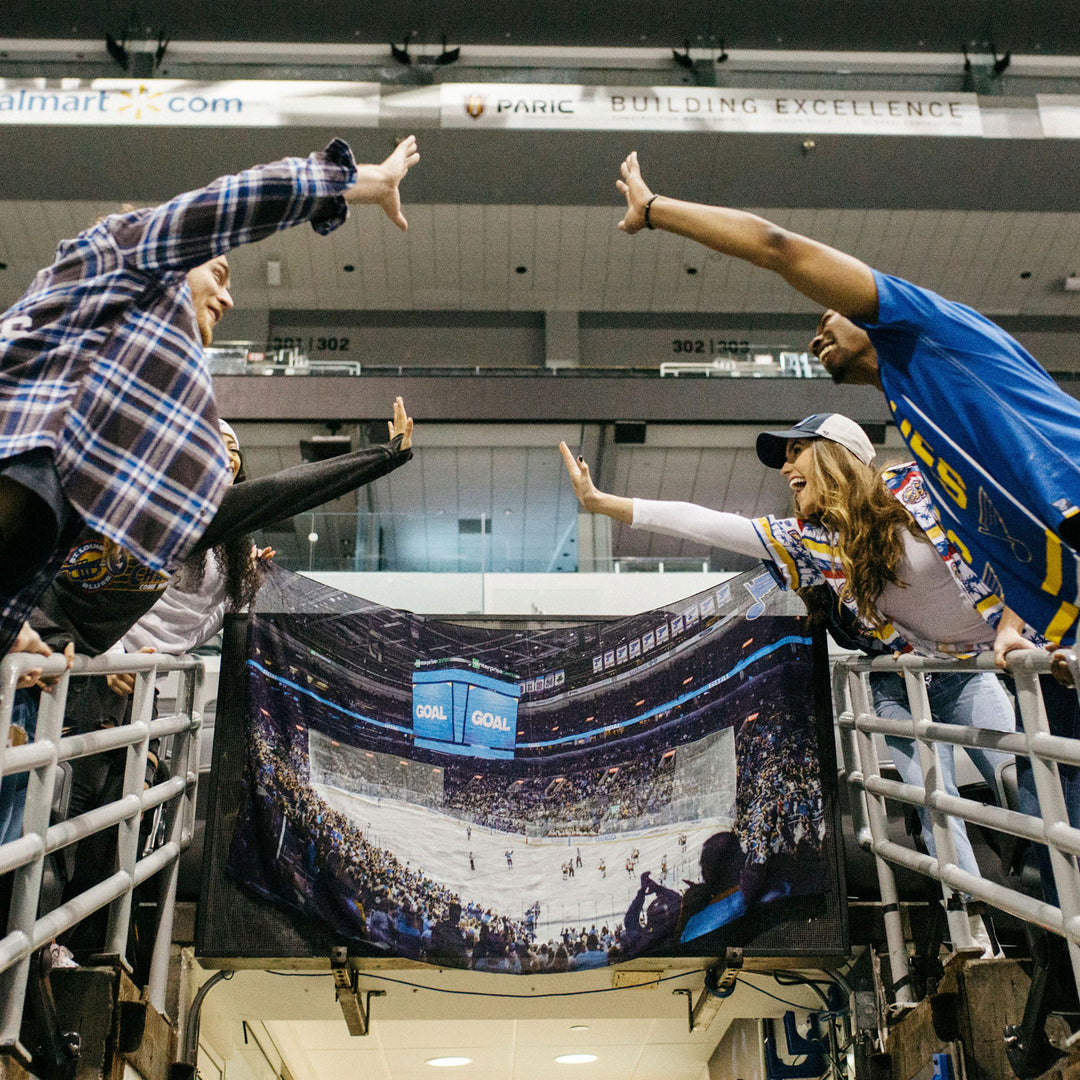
[221, 568, 842, 974]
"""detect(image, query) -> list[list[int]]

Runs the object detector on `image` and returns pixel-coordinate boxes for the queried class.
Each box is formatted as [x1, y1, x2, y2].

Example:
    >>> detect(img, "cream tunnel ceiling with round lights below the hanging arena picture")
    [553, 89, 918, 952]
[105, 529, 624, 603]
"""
[200, 963, 821, 1080]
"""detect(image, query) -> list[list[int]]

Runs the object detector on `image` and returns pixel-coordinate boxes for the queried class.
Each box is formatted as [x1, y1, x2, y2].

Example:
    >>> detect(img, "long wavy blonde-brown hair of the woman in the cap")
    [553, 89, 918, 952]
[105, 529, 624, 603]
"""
[808, 438, 930, 630]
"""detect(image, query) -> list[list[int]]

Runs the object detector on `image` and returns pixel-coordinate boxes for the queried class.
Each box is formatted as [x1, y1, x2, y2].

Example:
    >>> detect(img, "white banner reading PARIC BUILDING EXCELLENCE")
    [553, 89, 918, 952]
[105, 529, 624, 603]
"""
[442, 83, 983, 136]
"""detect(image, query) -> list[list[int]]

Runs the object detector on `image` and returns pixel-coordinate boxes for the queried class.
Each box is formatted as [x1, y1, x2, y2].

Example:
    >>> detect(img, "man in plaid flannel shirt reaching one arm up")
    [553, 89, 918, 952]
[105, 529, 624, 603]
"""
[0, 130, 419, 656]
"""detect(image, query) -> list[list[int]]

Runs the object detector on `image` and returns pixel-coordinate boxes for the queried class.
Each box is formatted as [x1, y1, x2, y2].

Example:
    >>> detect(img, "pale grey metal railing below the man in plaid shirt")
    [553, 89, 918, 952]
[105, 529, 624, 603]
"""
[0, 653, 202, 1045]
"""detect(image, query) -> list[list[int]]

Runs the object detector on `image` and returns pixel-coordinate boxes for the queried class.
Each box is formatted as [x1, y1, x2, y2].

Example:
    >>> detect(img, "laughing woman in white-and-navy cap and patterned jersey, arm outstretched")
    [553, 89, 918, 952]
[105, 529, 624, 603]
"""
[559, 413, 1043, 954]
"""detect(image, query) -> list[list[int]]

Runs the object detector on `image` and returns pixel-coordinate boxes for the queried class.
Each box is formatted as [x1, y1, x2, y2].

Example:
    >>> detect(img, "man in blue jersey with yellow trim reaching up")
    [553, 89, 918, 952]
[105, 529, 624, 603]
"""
[617, 147, 1080, 643]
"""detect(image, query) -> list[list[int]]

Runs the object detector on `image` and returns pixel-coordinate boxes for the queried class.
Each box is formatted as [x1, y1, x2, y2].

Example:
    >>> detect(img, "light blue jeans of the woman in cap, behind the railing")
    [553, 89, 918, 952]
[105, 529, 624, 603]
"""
[870, 672, 1016, 875]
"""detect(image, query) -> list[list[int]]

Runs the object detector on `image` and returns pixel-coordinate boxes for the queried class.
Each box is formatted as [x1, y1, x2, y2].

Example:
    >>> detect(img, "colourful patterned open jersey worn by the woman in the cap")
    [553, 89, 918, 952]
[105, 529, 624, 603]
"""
[754, 461, 1045, 657]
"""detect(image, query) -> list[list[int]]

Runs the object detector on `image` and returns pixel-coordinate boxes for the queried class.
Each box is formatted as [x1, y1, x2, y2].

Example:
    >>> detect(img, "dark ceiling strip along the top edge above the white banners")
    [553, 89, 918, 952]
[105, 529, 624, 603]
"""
[2, 0, 1080, 55]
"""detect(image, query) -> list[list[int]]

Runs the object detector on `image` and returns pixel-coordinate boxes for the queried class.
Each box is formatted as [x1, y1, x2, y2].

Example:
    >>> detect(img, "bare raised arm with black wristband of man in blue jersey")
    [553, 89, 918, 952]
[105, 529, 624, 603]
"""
[616, 150, 877, 321]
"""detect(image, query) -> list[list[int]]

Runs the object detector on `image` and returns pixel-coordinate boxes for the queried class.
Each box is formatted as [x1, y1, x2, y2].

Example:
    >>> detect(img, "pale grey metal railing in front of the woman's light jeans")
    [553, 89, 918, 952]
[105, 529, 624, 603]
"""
[833, 650, 1080, 1003]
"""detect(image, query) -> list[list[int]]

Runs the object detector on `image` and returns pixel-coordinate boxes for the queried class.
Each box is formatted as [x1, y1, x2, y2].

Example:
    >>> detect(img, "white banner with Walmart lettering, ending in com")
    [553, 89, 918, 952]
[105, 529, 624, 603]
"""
[0, 79, 379, 127]
